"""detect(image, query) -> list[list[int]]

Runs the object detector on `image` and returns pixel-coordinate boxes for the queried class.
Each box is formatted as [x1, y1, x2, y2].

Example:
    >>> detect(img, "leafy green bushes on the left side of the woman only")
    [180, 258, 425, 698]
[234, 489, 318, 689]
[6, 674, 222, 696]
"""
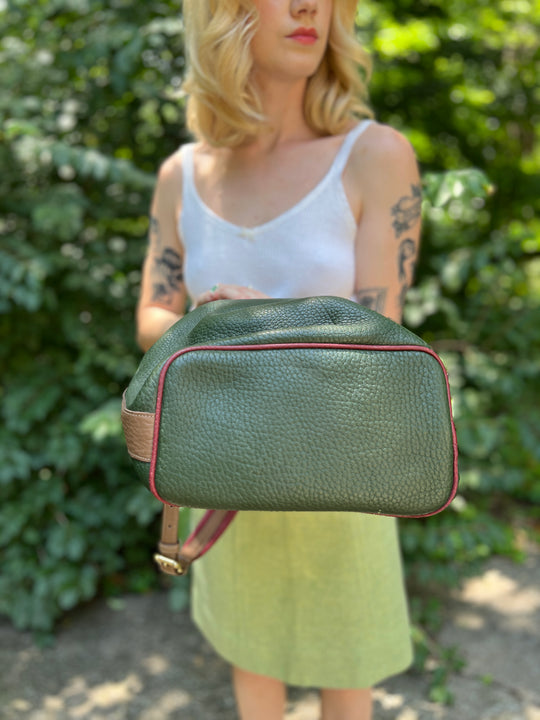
[0, 1, 188, 631]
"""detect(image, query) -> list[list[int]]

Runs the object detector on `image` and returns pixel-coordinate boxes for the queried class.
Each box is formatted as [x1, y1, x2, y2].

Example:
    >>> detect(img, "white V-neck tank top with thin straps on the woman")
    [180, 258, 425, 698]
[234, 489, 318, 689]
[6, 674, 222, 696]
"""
[179, 120, 371, 298]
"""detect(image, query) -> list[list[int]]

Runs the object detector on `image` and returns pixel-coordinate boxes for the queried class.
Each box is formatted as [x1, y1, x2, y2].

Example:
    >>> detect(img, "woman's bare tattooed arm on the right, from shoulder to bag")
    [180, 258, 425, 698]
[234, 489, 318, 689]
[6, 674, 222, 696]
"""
[348, 125, 422, 322]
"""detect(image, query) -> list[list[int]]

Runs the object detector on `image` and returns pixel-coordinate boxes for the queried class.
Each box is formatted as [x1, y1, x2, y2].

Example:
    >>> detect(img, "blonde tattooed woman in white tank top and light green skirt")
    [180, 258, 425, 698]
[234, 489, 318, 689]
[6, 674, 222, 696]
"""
[137, 0, 421, 720]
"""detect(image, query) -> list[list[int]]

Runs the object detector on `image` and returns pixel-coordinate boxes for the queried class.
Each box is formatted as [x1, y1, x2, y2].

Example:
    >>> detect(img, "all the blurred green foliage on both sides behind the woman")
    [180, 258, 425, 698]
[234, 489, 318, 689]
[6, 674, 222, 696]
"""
[0, 0, 540, 648]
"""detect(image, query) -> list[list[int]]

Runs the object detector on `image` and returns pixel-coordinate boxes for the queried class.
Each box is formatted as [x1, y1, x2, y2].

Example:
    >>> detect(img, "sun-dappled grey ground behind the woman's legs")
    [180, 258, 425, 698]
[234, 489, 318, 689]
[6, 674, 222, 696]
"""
[0, 547, 540, 720]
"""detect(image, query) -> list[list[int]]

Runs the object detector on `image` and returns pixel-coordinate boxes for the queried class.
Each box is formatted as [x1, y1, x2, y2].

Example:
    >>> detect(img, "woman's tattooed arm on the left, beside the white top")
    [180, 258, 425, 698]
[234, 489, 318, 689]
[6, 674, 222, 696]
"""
[137, 154, 187, 351]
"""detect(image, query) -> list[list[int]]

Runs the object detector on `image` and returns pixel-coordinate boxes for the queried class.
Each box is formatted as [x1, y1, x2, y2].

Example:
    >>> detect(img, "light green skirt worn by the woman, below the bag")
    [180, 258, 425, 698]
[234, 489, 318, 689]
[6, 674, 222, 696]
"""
[191, 511, 412, 688]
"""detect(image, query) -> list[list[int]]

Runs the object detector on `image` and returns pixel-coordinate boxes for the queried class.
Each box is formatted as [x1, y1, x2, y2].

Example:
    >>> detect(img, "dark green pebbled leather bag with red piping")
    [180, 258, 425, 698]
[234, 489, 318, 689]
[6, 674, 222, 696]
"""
[122, 296, 458, 572]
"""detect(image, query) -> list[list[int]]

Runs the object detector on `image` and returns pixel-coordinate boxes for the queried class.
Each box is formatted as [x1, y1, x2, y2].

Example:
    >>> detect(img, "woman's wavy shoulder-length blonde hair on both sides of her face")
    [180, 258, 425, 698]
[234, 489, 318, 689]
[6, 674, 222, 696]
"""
[184, 0, 373, 147]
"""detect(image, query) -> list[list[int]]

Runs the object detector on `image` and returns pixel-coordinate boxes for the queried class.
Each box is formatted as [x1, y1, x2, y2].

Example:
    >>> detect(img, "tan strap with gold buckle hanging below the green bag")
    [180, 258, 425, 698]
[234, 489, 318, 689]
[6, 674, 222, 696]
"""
[154, 505, 236, 575]
